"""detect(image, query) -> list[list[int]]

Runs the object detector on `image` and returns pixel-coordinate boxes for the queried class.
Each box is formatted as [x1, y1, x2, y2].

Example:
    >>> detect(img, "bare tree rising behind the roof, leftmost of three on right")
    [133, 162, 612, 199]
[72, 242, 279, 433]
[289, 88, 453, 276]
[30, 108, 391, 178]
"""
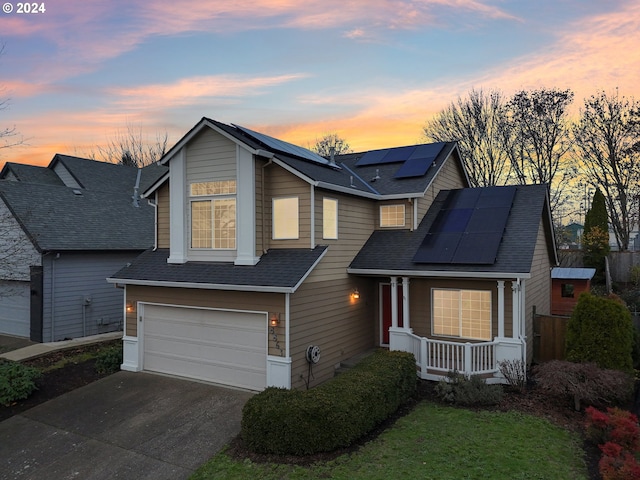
[423, 90, 509, 187]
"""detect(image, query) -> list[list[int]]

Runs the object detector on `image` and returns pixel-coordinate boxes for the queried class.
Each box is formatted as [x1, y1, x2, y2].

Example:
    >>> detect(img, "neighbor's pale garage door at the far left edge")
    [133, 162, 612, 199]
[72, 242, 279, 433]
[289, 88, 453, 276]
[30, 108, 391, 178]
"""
[0, 281, 31, 338]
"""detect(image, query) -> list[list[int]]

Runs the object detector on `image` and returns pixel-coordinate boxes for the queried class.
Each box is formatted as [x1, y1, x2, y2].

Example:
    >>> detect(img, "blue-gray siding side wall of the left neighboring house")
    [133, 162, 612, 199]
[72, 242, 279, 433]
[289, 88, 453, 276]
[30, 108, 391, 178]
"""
[42, 252, 140, 342]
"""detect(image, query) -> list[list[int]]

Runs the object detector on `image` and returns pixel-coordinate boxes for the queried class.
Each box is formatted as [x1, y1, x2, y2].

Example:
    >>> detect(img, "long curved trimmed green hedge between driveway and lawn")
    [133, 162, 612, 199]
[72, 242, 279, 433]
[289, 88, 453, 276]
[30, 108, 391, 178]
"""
[241, 350, 417, 455]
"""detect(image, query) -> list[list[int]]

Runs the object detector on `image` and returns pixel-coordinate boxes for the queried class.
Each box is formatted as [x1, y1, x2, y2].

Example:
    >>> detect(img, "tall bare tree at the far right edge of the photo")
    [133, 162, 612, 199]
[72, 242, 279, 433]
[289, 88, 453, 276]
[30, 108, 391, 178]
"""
[573, 91, 640, 250]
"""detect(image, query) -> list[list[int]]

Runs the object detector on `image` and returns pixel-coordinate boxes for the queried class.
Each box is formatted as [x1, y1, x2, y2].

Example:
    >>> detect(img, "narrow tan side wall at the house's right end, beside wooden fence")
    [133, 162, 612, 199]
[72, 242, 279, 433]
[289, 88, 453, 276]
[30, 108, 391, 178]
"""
[524, 220, 554, 363]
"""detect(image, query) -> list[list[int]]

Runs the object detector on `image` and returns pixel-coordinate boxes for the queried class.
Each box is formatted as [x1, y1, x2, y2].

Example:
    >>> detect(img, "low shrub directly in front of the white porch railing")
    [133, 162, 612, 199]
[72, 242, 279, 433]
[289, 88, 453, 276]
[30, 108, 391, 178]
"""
[435, 372, 502, 406]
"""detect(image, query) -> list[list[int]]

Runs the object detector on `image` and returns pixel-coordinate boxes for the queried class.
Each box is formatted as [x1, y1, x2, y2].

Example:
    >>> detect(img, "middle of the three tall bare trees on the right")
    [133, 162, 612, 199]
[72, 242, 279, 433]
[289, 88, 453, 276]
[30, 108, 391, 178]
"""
[502, 89, 575, 211]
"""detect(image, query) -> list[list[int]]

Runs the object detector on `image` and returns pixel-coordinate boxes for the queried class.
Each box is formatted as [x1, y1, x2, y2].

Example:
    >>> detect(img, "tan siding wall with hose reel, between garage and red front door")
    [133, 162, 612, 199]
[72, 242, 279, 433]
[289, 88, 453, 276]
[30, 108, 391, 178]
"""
[290, 277, 376, 388]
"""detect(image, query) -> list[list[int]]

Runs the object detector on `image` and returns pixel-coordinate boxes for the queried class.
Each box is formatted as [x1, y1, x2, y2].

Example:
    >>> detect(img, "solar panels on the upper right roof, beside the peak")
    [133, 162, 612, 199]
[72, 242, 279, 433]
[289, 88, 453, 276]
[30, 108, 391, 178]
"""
[356, 142, 445, 178]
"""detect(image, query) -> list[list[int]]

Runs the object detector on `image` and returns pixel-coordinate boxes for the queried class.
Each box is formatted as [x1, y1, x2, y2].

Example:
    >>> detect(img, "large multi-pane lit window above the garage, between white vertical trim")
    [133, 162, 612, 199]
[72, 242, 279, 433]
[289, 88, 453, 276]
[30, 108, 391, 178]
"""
[190, 180, 236, 250]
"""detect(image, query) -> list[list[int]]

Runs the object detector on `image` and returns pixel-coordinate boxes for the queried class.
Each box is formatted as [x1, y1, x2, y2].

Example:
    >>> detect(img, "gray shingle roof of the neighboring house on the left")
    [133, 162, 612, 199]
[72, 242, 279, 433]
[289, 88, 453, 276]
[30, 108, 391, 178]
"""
[0, 154, 168, 251]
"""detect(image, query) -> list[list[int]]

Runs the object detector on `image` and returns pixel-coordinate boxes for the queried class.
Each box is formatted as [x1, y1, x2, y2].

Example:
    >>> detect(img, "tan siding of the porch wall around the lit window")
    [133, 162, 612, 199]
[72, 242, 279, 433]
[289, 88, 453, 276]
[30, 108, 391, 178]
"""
[402, 278, 513, 341]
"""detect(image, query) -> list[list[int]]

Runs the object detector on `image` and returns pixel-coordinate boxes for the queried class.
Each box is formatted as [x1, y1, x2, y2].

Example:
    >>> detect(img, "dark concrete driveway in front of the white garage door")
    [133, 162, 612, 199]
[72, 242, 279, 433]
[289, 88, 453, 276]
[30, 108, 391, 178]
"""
[0, 372, 252, 480]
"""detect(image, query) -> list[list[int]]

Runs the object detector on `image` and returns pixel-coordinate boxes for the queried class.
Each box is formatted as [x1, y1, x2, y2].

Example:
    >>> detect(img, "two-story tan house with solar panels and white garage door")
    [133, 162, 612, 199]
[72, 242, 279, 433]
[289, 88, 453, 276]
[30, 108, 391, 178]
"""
[109, 118, 557, 390]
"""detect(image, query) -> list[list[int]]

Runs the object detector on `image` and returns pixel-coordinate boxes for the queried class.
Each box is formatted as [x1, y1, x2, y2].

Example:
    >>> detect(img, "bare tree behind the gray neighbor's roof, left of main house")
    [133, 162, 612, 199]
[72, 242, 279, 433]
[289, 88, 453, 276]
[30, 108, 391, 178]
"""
[88, 125, 169, 167]
